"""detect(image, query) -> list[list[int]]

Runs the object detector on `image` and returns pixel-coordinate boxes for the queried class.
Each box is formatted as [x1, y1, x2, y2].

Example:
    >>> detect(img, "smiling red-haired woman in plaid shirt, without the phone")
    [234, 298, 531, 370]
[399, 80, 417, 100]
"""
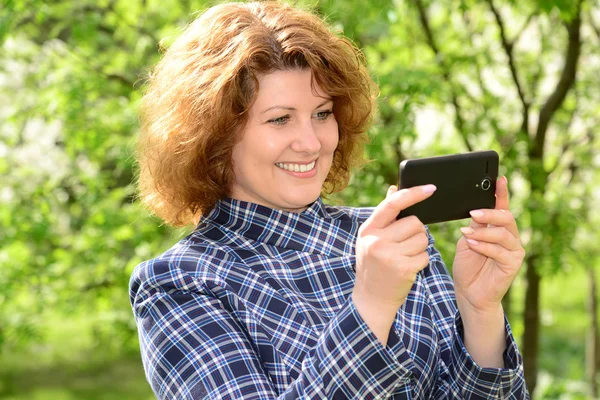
[130, 3, 529, 399]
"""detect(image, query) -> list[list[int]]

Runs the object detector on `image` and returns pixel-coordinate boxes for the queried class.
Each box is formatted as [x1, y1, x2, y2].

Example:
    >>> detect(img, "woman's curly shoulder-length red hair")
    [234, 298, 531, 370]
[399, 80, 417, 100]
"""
[137, 2, 377, 226]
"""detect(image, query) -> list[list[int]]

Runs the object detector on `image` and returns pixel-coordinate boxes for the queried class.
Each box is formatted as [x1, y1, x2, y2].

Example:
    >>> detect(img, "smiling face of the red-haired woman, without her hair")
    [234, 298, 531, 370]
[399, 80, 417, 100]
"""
[231, 69, 338, 212]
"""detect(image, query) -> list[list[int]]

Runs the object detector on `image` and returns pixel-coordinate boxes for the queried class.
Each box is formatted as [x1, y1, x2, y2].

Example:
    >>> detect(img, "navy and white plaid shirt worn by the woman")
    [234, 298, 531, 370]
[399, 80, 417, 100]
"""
[130, 199, 529, 400]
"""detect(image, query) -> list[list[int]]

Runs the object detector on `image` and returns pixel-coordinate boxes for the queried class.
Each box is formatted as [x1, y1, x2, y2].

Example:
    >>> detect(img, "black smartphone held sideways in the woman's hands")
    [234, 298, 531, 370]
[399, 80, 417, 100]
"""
[397, 150, 499, 224]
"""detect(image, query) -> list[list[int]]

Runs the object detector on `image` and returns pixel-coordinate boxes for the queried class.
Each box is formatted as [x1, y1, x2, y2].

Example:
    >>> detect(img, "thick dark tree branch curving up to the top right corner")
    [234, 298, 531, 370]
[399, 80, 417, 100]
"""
[530, 0, 582, 160]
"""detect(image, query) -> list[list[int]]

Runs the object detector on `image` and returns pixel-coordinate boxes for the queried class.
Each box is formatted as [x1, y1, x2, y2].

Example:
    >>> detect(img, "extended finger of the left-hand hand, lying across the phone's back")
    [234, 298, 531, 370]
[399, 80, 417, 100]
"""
[364, 185, 436, 229]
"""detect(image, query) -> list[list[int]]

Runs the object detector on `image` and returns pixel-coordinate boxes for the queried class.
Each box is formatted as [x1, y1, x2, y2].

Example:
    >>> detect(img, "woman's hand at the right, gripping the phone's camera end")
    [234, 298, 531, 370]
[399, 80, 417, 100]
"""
[453, 177, 525, 314]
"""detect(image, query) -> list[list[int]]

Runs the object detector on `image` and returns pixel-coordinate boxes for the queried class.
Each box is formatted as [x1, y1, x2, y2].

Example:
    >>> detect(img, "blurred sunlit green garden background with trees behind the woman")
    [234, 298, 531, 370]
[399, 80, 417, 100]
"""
[0, 0, 600, 400]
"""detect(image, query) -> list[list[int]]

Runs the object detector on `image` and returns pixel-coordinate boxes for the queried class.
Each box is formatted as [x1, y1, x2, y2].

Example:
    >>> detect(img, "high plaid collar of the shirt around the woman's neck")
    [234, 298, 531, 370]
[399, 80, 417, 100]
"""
[197, 197, 360, 255]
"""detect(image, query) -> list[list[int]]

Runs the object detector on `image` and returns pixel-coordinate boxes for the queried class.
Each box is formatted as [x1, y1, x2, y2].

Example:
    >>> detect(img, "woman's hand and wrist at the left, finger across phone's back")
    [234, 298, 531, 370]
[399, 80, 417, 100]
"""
[352, 185, 436, 344]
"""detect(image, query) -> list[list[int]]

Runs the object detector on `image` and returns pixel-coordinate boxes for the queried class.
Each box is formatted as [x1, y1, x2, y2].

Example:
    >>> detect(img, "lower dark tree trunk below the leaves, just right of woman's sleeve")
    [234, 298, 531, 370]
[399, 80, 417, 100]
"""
[523, 255, 541, 398]
